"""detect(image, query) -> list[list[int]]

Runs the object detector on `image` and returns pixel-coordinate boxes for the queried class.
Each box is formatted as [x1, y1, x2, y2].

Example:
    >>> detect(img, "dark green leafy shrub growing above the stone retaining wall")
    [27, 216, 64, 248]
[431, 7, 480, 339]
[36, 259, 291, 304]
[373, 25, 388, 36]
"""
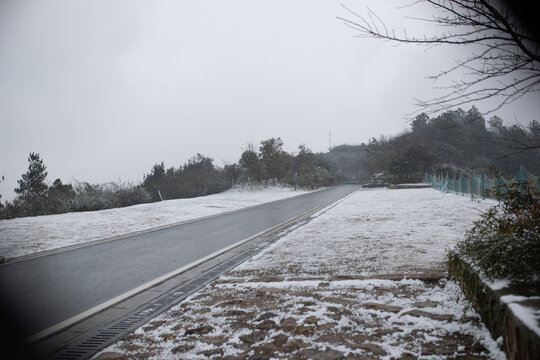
[450, 181, 540, 282]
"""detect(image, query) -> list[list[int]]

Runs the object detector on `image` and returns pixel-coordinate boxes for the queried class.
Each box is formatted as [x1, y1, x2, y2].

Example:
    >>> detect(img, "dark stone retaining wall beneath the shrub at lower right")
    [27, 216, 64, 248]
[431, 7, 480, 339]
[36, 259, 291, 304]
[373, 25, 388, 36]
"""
[448, 257, 540, 360]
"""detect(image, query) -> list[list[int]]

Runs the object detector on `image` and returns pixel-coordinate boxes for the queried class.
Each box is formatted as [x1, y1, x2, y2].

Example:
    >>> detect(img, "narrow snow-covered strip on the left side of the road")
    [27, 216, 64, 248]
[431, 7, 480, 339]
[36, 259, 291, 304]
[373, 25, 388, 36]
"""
[0, 187, 306, 259]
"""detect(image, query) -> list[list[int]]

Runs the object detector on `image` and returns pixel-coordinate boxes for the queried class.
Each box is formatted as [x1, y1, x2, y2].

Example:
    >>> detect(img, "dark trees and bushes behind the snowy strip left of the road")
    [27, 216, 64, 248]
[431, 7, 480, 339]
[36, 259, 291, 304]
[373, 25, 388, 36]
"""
[0, 138, 339, 219]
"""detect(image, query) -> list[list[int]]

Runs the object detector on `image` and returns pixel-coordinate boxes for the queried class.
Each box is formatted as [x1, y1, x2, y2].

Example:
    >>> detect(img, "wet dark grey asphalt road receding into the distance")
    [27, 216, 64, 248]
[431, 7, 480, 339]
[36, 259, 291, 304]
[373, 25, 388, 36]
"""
[0, 185, 358, 337]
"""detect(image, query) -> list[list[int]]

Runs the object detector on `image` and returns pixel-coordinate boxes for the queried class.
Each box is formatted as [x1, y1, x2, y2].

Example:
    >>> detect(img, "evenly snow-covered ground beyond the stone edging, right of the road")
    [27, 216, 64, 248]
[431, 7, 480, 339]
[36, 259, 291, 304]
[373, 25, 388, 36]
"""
[230, 188, 497, 276]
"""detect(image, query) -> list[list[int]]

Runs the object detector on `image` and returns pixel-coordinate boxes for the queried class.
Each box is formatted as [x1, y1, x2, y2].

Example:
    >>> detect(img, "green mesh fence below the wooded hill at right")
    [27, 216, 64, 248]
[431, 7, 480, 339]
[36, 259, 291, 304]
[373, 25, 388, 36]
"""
[425, 167, 540, 198]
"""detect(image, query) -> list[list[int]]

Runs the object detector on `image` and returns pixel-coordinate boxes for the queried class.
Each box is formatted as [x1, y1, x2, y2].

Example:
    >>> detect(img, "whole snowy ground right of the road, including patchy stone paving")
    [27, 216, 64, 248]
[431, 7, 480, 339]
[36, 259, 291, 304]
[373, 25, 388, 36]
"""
[96, 189, 506, 360]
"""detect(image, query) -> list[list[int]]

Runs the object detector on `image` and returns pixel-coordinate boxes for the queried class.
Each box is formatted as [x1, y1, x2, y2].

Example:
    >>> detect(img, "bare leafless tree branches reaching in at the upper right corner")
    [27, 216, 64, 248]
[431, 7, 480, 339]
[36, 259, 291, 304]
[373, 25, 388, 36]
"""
[339, 0, 540, 115]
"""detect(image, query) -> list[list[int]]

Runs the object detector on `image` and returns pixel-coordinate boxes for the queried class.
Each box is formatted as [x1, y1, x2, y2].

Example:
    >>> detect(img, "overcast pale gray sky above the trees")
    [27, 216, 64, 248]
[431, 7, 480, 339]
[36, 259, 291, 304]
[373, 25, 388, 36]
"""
[0, 0, 540, 200]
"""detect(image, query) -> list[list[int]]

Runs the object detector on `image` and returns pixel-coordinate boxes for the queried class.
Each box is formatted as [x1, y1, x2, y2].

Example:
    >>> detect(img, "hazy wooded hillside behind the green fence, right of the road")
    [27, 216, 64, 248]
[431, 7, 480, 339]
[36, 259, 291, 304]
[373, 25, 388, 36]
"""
[325, 106, 540, 183]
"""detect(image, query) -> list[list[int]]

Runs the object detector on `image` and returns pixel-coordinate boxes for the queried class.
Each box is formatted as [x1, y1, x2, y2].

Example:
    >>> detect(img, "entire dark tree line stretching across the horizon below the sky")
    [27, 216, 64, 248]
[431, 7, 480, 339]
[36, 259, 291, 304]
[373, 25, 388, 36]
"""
[0, 106, 540, 219]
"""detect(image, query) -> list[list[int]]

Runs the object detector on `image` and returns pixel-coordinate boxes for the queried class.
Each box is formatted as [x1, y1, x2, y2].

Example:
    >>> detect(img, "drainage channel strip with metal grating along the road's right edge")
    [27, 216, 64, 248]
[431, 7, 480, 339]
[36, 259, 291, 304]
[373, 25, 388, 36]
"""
[31, 204, 330, 360]
